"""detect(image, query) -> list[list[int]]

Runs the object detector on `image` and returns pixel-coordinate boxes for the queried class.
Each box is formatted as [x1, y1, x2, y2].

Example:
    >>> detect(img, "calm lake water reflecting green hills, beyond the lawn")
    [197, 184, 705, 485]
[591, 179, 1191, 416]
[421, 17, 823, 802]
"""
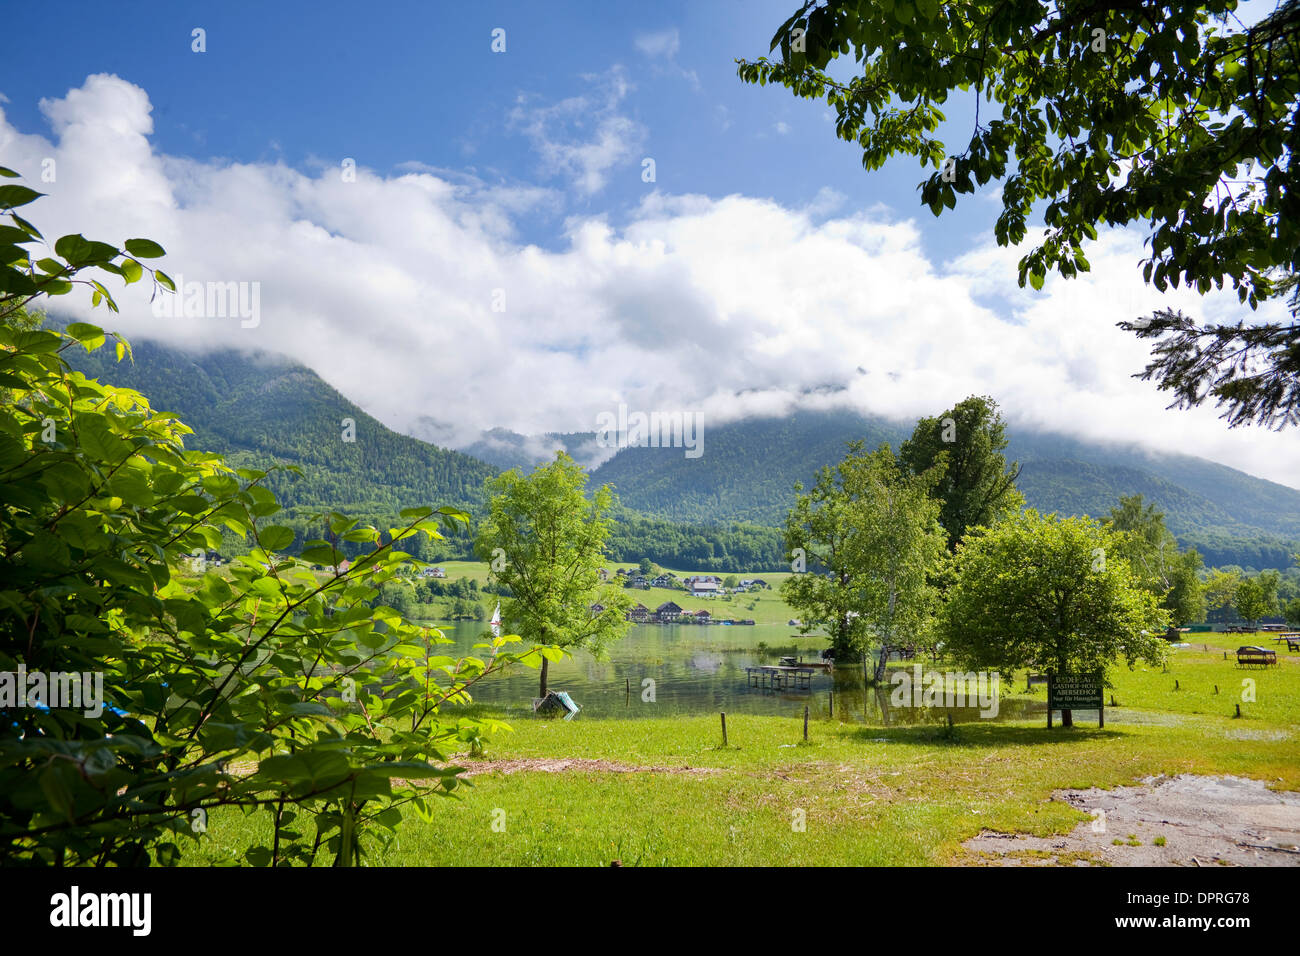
[441, 623, 1047, 726]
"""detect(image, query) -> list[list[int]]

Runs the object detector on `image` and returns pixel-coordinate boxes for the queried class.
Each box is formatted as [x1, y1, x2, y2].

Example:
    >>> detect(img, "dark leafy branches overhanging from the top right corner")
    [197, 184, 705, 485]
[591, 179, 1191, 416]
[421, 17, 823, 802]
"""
[738, 0, 1300, 427]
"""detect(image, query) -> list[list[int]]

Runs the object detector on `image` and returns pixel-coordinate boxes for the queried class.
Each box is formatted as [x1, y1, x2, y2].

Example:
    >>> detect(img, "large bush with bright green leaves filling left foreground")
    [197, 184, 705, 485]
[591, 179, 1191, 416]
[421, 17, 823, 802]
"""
[0, 170, 541, 865]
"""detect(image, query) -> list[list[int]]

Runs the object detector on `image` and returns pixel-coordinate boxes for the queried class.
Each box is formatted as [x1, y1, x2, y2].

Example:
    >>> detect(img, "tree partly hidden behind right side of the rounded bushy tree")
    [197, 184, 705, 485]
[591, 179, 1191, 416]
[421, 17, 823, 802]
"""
[1106, 494, 1206, 626]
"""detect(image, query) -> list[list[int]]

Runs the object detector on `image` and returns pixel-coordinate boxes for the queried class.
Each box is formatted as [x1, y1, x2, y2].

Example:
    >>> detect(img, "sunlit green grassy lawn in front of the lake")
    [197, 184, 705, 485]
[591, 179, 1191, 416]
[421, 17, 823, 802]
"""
[187, 635, 1300, 865]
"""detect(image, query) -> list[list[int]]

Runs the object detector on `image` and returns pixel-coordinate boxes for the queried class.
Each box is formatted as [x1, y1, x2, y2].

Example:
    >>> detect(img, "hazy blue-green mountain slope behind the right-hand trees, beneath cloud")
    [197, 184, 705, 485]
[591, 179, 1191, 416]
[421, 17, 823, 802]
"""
[593, 411, 1300, 567]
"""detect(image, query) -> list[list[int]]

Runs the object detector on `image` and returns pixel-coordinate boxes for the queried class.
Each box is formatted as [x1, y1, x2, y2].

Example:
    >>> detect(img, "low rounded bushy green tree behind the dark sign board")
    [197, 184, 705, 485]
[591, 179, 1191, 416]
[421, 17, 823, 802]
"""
[939, 509, 1169, 727]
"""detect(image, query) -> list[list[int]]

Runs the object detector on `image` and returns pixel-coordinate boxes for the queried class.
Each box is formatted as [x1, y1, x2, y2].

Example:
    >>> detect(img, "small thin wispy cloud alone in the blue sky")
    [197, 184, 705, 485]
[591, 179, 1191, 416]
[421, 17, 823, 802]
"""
[510, 66, 646, 196]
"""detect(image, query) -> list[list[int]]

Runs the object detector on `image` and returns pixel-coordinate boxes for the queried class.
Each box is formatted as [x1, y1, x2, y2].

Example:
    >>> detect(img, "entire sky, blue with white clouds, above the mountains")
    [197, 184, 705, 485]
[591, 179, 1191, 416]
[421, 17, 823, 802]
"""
[0, 0, 1300, 484]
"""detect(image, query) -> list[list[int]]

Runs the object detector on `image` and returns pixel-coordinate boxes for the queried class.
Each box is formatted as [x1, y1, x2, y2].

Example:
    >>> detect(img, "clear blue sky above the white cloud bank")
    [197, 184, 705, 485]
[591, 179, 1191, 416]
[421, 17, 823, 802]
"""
[0, 0, 996, 258]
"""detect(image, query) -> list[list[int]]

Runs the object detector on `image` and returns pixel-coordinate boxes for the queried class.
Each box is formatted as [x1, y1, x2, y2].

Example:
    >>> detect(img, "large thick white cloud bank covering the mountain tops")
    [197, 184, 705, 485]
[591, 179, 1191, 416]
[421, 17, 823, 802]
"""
[10, 75, 1300, 494]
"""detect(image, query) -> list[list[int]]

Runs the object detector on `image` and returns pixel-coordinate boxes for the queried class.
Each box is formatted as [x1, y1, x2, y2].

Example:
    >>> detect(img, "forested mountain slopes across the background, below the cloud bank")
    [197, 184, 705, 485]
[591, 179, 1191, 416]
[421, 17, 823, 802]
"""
[70, 332, 1300, 570]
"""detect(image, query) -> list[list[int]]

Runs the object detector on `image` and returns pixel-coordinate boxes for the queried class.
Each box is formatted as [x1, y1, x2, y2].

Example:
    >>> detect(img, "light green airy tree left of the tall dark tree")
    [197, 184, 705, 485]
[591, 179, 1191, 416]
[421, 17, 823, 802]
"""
[781, 442, 943, 679]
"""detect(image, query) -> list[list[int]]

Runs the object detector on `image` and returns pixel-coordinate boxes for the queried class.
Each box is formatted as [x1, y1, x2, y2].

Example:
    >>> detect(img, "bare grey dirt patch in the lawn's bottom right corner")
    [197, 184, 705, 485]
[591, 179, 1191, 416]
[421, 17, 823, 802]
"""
[962, 774, 1300, 866]
